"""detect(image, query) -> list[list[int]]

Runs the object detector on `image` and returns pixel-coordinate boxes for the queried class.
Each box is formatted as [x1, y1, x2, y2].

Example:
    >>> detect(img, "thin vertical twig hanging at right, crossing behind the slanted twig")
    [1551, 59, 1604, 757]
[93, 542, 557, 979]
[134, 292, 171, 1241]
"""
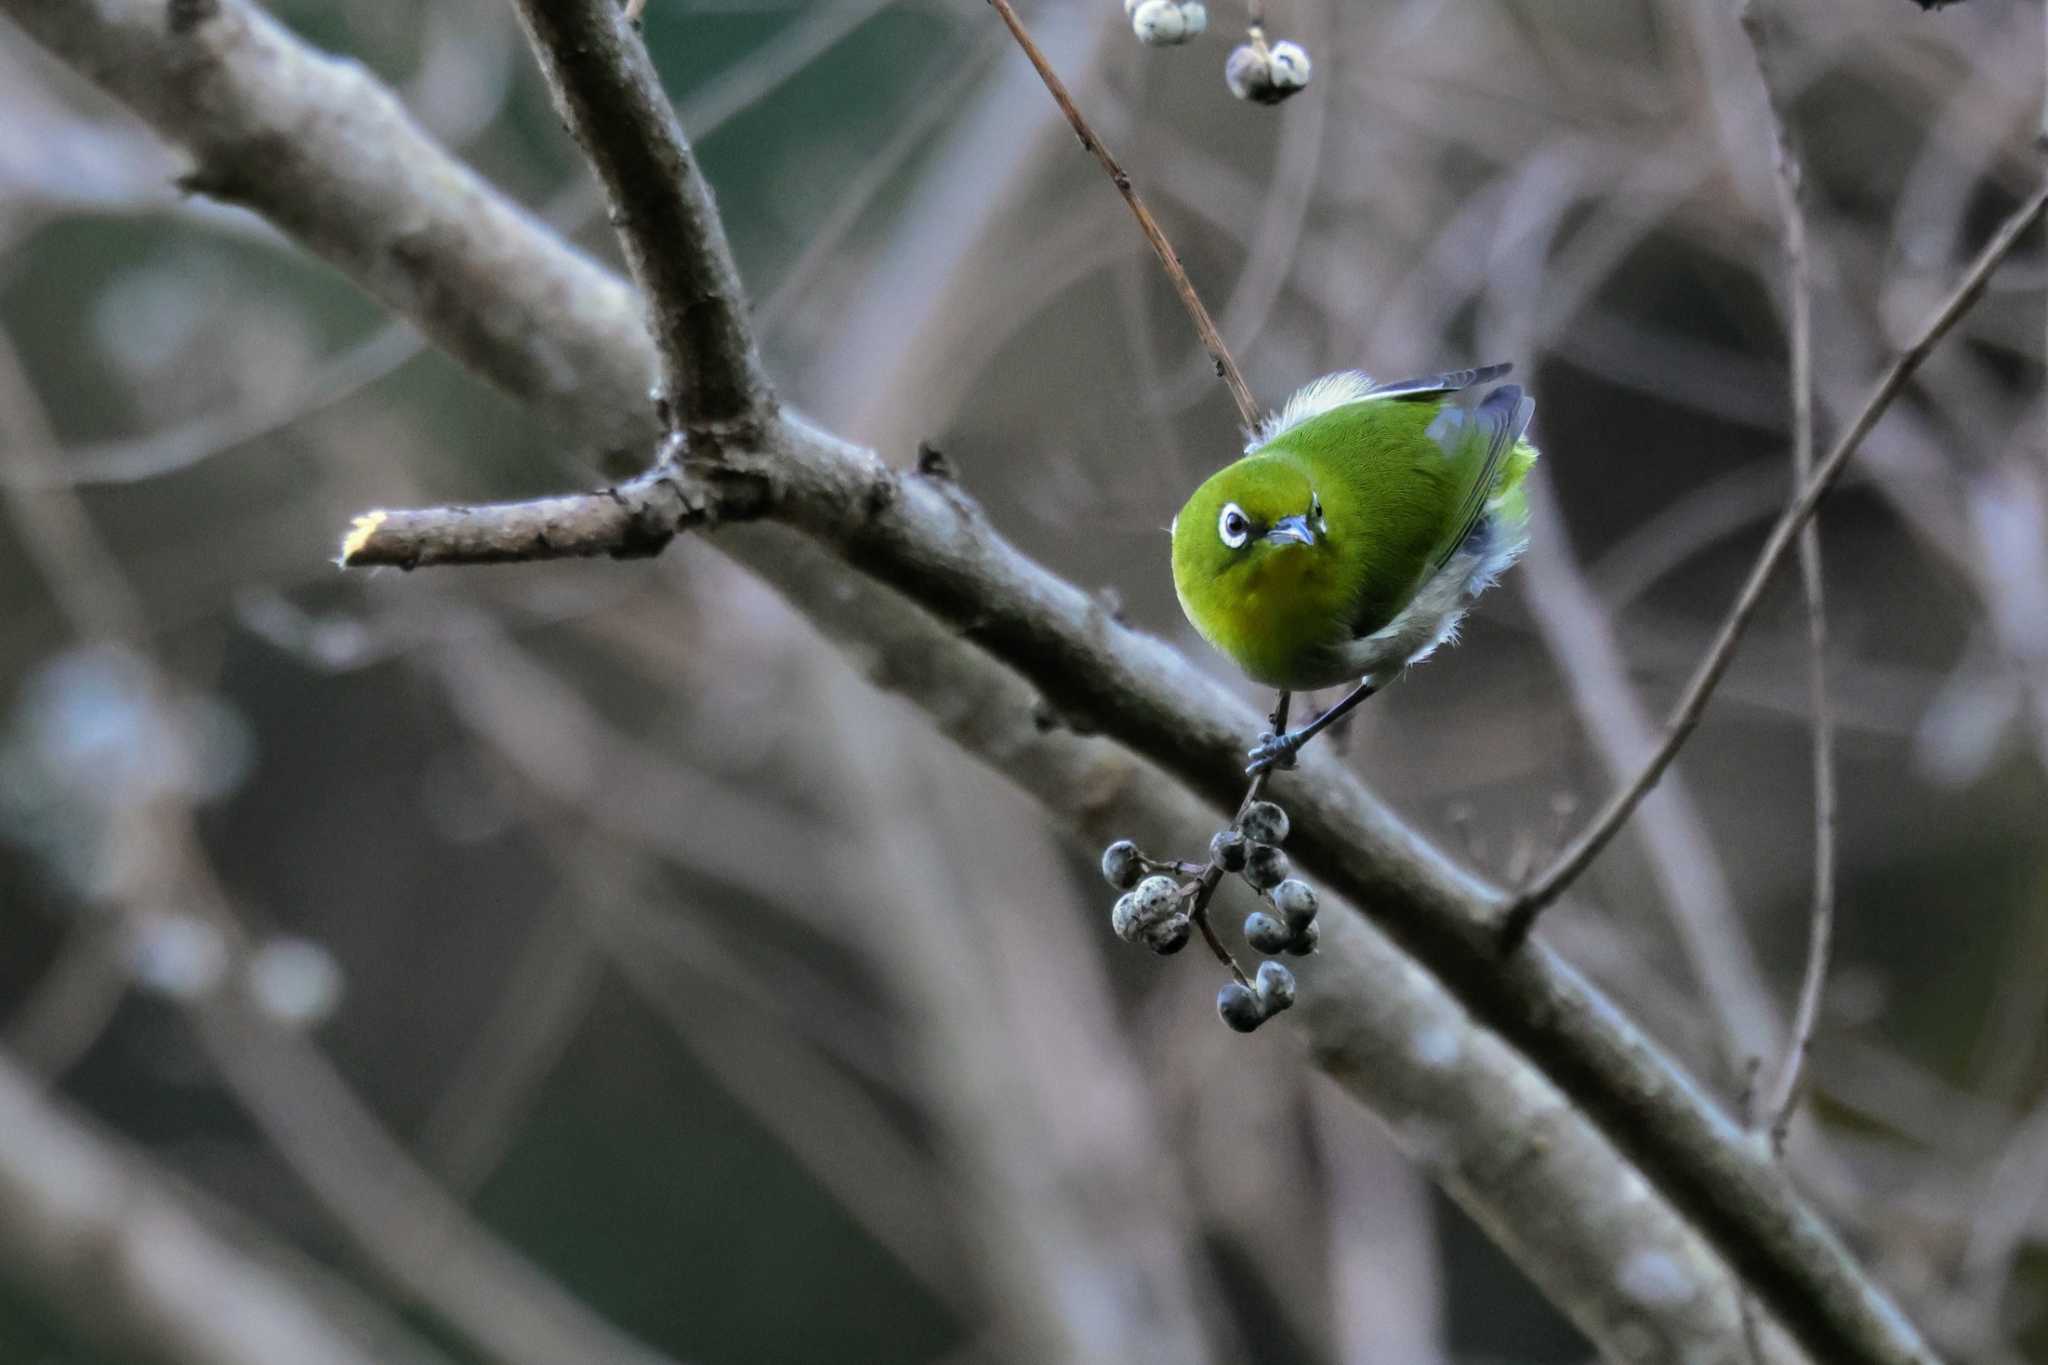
[1737, 0, 1835, 1152]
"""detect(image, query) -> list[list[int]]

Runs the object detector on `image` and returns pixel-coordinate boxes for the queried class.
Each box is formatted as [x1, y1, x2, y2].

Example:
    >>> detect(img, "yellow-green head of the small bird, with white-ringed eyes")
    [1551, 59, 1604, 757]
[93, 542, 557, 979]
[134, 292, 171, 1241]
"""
[1174, 452, 1335, 653]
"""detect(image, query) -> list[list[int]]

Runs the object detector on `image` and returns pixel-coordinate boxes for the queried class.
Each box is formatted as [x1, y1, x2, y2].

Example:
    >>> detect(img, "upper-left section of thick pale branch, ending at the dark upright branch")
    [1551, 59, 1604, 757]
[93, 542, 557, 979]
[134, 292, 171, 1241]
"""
[4, 0, 655, 448]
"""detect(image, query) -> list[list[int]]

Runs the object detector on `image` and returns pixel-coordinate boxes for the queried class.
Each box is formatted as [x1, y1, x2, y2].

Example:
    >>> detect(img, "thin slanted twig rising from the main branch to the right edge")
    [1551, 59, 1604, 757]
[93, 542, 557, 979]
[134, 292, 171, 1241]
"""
[1501, 175, 2048, 952]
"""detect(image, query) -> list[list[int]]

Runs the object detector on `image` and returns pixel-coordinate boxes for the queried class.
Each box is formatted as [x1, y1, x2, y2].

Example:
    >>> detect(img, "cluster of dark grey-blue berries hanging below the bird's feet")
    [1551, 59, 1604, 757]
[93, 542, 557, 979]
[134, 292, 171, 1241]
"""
[1102, 800, 1321, 1033]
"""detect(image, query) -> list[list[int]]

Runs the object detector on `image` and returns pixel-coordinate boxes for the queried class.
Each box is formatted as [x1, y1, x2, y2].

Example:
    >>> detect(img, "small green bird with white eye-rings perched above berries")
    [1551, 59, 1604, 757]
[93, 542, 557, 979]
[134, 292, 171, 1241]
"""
[1174, 364, 1536, 774]
